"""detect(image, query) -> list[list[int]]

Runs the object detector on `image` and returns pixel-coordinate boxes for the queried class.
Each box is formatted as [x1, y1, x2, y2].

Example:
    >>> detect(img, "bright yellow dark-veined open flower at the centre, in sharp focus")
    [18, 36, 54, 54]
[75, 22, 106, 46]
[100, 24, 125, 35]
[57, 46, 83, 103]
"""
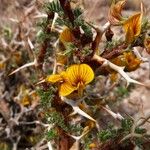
[46, 64, 94, 96]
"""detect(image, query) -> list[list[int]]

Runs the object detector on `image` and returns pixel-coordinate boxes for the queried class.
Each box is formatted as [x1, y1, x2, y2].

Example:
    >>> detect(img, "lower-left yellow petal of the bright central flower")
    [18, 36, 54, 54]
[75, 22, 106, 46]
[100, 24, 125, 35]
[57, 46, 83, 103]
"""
[59, 82, 77, 96]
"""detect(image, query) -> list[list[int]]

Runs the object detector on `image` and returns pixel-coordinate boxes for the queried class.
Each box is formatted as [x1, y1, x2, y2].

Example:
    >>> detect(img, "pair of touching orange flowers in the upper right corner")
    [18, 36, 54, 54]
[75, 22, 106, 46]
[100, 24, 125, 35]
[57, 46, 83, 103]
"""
[108, 0, 143, 44]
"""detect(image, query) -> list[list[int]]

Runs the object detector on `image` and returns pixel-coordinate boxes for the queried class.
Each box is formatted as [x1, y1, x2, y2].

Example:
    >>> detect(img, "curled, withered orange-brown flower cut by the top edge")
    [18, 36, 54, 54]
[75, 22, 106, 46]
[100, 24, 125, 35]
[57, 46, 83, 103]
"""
[108, 0, 126, 25]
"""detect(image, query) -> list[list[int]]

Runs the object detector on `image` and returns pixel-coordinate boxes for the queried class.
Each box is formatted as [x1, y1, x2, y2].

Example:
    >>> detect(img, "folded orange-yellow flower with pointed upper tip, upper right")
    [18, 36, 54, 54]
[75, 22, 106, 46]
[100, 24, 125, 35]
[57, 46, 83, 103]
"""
[123, 13, 143, 43]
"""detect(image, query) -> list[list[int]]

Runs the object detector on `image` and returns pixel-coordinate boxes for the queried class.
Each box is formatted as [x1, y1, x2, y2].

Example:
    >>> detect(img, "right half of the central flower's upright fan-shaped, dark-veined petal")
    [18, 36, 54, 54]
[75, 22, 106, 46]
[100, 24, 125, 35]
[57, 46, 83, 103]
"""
[79, 64, 94, 84]
